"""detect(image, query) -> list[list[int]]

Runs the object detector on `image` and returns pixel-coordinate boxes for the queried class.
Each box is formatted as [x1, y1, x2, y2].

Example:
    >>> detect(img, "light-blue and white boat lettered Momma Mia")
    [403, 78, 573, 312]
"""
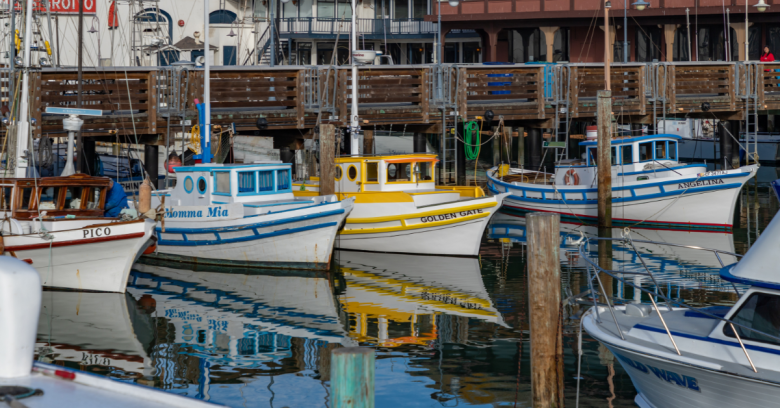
[146, 162, 354, 269]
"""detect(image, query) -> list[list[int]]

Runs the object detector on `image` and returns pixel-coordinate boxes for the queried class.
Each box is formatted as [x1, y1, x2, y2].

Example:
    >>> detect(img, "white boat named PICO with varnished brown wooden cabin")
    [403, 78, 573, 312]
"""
[0, 174, 154, 292]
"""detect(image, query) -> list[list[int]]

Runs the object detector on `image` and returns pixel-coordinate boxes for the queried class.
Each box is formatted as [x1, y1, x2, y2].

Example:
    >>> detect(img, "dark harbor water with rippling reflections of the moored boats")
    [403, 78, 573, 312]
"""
[36, 182, 778, 407]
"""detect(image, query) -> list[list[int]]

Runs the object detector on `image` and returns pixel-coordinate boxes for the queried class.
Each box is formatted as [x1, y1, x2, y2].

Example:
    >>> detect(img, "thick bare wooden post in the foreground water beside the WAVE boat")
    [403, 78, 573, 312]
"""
[527, 213, 563, 408]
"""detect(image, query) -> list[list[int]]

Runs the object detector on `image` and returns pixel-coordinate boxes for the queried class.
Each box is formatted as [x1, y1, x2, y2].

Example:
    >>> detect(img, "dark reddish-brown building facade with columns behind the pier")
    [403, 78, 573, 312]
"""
[426, 0, 780, 62]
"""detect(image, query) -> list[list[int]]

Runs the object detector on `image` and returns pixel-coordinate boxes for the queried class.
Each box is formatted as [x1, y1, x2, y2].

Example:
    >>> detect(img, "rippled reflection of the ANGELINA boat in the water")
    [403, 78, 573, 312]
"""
[488, 212, 737, 291]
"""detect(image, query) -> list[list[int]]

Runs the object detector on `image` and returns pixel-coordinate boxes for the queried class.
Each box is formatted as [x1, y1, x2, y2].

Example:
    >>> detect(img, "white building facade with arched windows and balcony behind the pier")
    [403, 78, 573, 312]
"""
[0, 0, 482, 66]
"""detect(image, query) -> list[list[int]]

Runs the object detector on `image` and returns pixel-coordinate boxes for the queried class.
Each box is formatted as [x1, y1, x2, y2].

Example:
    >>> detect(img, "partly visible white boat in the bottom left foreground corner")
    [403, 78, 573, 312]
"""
[0, 256, 222, 408]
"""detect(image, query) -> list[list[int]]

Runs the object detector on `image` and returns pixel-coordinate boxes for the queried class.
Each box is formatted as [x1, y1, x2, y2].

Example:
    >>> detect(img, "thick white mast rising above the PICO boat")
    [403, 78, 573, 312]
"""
[11, 0, 33, 177]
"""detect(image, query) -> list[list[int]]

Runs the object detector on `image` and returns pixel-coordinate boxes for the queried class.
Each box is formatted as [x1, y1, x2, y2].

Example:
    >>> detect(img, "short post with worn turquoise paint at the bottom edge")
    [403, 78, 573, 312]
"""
[330, 347, 374, 408]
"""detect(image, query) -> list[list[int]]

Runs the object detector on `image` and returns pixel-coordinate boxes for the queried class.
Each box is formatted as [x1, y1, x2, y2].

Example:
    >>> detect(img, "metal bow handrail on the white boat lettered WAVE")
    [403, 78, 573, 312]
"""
[579, 237, 780, 373]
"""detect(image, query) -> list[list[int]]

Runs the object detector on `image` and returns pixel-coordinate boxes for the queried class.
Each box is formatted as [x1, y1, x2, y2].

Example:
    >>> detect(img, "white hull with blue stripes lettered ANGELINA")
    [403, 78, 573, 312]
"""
[488, 166, 755, 231]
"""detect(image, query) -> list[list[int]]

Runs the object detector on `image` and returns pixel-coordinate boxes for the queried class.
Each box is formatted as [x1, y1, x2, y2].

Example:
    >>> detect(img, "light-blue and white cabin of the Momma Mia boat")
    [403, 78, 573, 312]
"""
[165, 162, 294, 206]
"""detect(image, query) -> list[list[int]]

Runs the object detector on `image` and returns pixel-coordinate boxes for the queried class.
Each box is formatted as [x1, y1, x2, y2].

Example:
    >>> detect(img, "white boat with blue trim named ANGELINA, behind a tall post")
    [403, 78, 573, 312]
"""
[488, 135, 758, 230]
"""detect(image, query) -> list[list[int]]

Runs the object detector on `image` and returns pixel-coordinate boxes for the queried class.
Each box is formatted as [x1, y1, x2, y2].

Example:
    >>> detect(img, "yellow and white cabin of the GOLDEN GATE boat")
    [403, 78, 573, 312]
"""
[335, 154, 439, 193]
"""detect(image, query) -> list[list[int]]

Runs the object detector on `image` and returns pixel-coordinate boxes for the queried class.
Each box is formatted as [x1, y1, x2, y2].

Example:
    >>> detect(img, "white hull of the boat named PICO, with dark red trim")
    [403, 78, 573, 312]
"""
[3, 220, 154, 293]
